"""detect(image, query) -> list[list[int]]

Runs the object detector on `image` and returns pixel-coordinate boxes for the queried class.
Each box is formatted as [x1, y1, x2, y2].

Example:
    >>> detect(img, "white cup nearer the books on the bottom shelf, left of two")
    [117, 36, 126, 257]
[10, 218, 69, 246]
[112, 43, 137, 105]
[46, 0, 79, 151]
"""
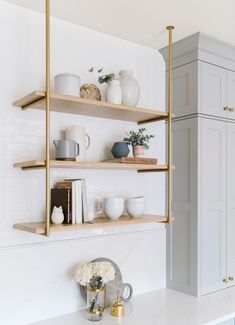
[104, 197, 124, 220]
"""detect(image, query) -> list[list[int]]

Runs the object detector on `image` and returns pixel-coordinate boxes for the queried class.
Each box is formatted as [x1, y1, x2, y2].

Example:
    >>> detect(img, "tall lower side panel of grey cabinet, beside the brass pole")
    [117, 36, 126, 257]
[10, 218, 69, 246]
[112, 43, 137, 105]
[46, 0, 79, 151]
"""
[167, 118, 197, 295]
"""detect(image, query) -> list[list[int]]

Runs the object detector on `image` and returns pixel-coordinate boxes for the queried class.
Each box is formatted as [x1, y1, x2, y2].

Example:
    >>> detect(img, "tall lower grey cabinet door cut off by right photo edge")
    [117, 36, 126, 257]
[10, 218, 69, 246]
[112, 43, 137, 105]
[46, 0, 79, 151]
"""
[227, 123, 235, 286]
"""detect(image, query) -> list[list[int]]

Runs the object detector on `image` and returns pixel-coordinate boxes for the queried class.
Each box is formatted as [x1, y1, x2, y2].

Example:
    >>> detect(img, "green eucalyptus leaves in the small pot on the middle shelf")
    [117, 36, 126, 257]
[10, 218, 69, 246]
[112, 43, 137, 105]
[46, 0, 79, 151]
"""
[123, 128, 155, 149]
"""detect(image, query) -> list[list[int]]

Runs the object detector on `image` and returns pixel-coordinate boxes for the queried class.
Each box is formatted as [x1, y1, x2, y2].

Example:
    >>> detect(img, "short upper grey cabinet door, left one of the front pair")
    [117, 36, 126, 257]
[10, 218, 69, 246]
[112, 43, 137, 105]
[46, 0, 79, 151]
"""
[201, 62, 227, 117]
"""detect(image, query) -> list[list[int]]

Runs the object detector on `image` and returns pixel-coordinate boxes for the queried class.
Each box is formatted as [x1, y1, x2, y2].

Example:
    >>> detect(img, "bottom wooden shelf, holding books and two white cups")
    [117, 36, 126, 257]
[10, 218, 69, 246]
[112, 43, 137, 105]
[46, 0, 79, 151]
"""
[13, 215, 168, 235]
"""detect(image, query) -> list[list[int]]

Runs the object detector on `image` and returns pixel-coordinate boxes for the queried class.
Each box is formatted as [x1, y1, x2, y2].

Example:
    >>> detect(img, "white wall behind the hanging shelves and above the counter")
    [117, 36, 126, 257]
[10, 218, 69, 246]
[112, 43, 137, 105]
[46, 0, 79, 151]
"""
[0, 1, 165, 325]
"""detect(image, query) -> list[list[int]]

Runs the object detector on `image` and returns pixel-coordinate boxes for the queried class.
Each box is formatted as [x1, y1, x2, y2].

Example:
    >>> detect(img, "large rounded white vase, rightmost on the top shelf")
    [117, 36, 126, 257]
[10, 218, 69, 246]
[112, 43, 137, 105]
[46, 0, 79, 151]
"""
[119, 70, 140, 107]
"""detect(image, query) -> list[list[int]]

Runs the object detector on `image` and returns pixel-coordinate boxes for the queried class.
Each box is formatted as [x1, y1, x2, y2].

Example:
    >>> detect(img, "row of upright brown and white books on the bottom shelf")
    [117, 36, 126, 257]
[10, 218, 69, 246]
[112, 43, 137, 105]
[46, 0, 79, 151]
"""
[51, 179, 89, 224]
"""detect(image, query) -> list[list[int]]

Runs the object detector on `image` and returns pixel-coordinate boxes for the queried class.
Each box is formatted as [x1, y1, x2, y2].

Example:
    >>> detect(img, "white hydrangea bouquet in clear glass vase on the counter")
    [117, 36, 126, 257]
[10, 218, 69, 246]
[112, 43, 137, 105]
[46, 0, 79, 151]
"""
[75, 262, 115, 321]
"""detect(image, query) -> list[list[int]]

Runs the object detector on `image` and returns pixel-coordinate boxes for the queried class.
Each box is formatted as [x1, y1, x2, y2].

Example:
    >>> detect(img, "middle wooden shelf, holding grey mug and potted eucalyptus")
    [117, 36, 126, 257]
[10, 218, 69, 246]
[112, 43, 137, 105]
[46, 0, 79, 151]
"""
[13, 160, 171, 172]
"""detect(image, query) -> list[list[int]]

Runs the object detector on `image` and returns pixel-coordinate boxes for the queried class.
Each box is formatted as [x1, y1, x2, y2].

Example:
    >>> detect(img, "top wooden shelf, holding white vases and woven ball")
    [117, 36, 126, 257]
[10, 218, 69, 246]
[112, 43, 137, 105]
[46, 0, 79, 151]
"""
[13, 91, 171, 124]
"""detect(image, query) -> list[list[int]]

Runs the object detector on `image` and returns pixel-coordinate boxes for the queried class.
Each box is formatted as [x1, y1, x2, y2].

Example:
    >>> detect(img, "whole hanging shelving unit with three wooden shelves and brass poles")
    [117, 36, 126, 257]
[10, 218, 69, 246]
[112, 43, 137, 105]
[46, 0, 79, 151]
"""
[13, 0, 174, 236]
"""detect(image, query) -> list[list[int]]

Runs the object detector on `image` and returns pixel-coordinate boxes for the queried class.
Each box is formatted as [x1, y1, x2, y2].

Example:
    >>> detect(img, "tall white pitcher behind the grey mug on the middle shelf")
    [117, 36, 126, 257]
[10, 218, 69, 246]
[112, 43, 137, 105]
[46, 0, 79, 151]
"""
[66, 125, 90, 161]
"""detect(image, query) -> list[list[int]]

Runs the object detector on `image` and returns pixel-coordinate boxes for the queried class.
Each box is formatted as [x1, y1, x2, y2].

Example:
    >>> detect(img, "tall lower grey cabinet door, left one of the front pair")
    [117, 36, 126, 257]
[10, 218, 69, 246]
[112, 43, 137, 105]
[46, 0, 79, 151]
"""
[199, 119, 227, 294]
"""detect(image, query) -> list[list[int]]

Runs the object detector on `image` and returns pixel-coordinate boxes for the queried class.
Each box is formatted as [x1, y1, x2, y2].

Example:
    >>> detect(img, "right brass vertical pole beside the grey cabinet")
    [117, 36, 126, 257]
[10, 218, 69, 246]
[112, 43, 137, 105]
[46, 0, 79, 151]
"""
[167, 26, 174, 223]
